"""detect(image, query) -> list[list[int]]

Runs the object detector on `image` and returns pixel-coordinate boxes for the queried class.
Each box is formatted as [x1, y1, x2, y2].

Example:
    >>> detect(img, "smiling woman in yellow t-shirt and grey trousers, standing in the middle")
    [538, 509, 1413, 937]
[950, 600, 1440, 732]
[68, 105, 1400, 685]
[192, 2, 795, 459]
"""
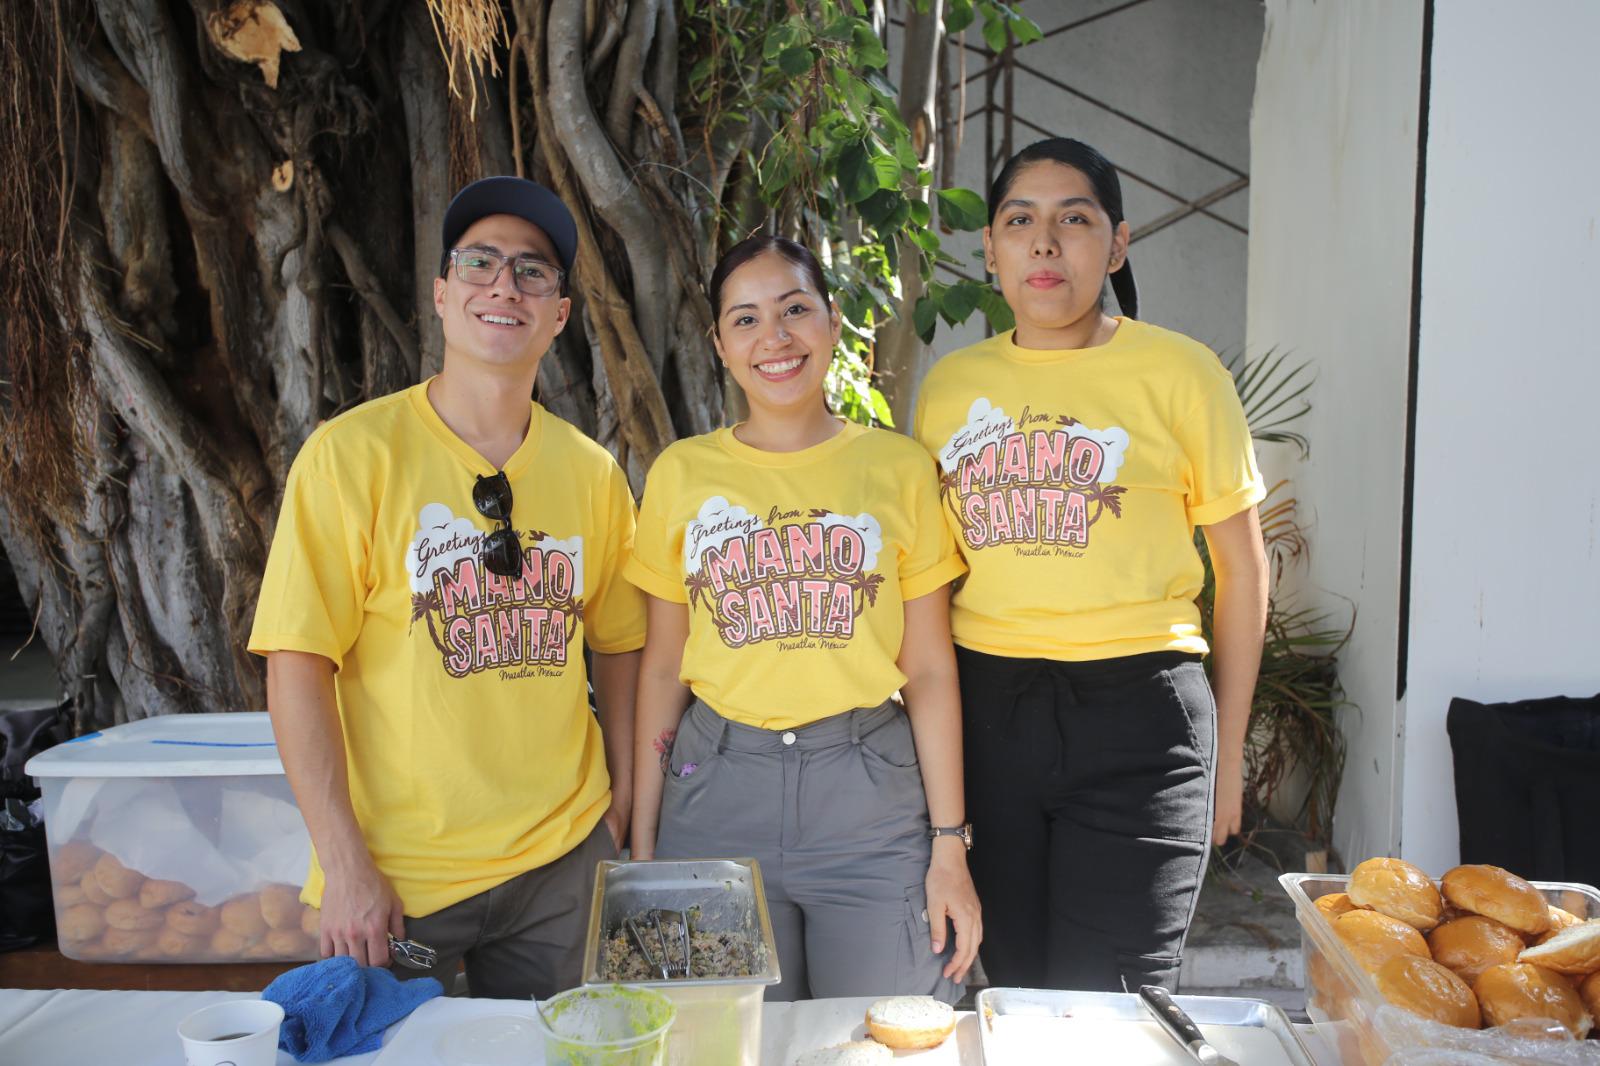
[622, 237, 981, 1002]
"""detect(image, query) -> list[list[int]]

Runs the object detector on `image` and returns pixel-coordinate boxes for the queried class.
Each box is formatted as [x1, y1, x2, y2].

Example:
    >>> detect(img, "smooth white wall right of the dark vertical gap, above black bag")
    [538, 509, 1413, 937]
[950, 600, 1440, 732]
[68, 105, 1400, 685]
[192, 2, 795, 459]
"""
[1401, 0, 1600, 871]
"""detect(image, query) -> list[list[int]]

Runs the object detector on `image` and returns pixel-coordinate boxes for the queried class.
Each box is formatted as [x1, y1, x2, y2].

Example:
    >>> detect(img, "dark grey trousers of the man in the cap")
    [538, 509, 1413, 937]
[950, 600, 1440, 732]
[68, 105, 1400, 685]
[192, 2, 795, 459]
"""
[390, 820, 616, 999]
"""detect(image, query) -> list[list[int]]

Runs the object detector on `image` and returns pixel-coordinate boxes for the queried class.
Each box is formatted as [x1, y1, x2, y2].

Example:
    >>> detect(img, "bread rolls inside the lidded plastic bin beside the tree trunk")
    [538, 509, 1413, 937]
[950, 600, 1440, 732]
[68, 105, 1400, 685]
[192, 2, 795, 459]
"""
[51, 840, 318, 962]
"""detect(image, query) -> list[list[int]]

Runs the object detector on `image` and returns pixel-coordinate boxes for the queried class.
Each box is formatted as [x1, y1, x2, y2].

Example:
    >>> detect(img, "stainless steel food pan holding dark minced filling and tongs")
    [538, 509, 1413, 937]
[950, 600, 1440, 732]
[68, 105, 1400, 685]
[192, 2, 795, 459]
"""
[584, 860, 782, 986]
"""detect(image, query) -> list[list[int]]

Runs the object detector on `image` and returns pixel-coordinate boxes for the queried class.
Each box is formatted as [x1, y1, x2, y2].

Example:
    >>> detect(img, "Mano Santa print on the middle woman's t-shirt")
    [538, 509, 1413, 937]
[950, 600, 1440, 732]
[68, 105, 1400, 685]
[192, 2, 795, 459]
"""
[683, 496, 883, 651]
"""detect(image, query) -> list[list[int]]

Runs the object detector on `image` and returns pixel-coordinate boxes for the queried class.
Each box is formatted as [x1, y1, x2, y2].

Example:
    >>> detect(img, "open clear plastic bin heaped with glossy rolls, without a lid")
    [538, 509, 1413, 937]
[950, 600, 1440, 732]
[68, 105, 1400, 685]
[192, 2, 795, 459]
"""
[1278, 874, 1600, 1066]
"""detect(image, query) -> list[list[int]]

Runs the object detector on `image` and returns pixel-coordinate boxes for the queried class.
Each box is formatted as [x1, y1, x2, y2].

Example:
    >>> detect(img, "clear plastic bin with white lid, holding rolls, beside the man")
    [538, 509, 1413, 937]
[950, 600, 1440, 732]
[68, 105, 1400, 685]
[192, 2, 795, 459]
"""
[27, 712, 317, 962]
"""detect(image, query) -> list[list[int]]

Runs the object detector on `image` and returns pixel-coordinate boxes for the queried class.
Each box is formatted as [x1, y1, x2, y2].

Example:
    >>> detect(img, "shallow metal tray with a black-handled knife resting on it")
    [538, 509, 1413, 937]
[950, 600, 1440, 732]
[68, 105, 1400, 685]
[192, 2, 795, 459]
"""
[978, 988, 1317, 1066]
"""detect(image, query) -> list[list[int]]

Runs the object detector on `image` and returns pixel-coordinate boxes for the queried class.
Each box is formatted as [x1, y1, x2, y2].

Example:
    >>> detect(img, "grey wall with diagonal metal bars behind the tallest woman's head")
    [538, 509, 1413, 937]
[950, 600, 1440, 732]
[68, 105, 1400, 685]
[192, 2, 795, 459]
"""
[928, 0, 1262, 355]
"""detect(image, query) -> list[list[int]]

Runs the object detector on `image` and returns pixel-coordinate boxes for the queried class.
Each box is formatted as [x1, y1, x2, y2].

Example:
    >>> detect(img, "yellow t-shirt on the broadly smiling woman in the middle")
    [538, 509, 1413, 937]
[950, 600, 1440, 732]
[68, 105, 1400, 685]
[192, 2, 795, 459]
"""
[622, 423, 963, 730]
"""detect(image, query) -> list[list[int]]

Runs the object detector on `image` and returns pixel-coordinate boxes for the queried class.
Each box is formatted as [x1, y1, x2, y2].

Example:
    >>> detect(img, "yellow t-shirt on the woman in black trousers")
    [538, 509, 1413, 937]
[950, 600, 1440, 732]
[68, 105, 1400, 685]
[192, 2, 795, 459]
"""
[914, 319, 1266, 659]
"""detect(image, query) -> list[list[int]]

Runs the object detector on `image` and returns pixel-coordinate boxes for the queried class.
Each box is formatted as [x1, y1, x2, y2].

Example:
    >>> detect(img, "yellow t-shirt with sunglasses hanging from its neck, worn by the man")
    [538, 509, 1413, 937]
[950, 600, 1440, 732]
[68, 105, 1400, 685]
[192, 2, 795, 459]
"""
[250, 383, 645, 917]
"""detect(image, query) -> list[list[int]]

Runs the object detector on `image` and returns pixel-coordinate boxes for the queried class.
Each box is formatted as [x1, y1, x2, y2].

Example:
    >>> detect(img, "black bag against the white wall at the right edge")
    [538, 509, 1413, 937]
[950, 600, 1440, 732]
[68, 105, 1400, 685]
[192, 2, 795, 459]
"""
[1446, 696, 1600, 885]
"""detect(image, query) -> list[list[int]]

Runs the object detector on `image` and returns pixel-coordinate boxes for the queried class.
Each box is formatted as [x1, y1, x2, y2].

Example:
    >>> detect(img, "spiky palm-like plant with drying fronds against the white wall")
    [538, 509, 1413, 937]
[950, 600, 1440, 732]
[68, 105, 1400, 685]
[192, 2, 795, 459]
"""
[1195, 351, 1354, 847]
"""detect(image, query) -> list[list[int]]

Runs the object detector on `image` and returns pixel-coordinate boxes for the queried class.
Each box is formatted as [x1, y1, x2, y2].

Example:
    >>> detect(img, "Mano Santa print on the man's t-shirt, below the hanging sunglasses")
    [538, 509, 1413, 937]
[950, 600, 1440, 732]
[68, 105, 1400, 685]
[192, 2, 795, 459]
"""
[406, 503, 584, 679]
